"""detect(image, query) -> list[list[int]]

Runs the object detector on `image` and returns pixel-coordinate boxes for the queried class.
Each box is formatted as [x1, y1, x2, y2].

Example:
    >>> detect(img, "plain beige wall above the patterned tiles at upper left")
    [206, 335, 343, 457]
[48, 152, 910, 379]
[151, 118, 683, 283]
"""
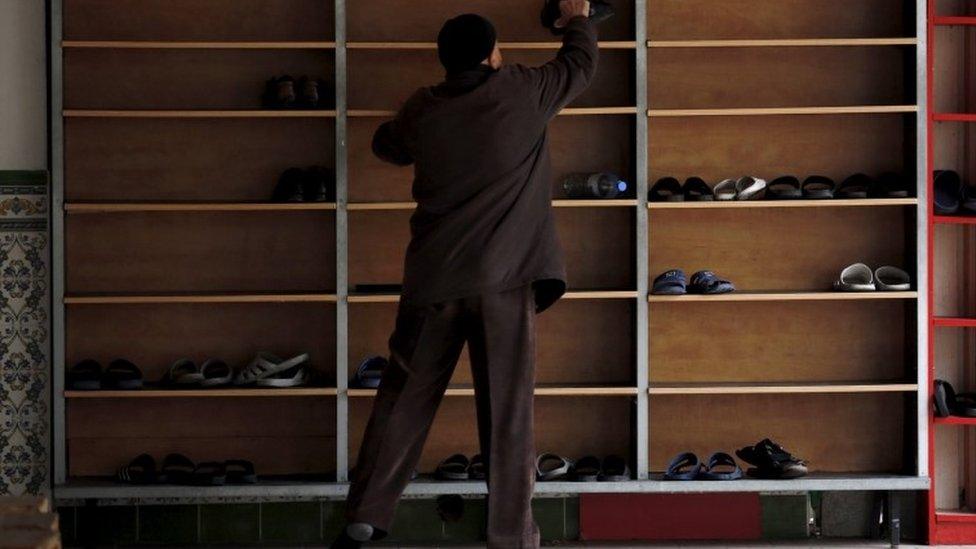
[0, 0, 47, 170]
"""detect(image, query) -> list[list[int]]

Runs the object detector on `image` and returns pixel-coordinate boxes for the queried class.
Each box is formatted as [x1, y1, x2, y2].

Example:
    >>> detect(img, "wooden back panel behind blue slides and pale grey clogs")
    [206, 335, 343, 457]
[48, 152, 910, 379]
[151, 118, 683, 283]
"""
[650, 208, 912, 291]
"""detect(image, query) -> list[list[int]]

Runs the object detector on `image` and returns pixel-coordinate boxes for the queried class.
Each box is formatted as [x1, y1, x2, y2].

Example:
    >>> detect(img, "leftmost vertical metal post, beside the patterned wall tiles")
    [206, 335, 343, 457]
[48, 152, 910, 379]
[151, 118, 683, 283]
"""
[48, 0, 68, 486]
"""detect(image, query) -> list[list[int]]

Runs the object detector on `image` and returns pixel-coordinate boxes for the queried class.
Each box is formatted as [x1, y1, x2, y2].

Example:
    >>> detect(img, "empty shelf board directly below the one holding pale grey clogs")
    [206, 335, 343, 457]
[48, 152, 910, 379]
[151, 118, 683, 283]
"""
[647, 381, 918, 395]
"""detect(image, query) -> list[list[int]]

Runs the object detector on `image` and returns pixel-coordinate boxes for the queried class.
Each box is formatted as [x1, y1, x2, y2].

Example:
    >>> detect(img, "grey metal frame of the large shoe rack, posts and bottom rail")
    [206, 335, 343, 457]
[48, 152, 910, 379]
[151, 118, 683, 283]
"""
[49, 0, 930, 503]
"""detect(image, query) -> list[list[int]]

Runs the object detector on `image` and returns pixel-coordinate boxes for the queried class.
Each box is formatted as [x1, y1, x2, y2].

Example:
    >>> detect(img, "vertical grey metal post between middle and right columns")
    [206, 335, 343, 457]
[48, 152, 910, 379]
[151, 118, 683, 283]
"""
[634, 0, 650, 479]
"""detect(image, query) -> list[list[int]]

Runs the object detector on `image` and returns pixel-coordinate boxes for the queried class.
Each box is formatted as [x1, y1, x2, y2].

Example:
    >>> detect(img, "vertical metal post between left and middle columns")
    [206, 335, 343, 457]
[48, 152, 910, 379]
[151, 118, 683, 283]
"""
[335, 0, 349, 482]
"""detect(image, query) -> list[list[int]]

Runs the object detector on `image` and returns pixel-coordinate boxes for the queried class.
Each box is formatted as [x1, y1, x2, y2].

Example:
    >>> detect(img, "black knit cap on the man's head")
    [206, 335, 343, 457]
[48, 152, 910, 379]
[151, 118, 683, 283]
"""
[437, 13, 495, 73]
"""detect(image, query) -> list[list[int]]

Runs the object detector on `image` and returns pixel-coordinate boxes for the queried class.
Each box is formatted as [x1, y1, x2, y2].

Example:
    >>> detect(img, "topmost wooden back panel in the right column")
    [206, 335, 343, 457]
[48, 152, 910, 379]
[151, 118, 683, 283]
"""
[647, 0, 915, 40]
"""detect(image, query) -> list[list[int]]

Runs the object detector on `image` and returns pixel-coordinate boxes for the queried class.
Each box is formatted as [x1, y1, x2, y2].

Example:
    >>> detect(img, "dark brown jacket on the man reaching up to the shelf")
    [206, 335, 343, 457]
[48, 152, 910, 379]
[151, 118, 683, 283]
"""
[373, 17, 598, 311]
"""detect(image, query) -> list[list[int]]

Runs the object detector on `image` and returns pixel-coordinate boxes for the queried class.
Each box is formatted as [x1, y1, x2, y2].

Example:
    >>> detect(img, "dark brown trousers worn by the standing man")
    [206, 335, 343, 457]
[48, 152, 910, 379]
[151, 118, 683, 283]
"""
[347, 286, 539, 548]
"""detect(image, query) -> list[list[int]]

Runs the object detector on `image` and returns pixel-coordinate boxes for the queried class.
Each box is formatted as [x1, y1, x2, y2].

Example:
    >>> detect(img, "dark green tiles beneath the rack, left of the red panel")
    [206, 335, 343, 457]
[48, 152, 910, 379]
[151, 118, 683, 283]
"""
[58, 498, 579, 547]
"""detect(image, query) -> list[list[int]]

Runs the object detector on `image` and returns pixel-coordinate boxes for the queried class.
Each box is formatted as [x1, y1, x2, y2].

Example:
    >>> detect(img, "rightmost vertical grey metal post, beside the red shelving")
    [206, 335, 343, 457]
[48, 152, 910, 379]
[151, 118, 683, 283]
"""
[915, 0, 934, 477]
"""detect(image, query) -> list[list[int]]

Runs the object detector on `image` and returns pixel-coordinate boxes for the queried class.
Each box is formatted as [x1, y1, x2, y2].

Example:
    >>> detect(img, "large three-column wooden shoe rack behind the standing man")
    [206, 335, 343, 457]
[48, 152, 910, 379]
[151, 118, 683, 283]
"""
[51, 0, 929, 512]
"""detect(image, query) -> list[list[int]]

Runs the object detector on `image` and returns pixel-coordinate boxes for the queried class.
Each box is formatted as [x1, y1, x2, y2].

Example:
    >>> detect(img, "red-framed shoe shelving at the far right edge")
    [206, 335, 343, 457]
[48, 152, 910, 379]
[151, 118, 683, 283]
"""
[927, 0, 976, 544]
